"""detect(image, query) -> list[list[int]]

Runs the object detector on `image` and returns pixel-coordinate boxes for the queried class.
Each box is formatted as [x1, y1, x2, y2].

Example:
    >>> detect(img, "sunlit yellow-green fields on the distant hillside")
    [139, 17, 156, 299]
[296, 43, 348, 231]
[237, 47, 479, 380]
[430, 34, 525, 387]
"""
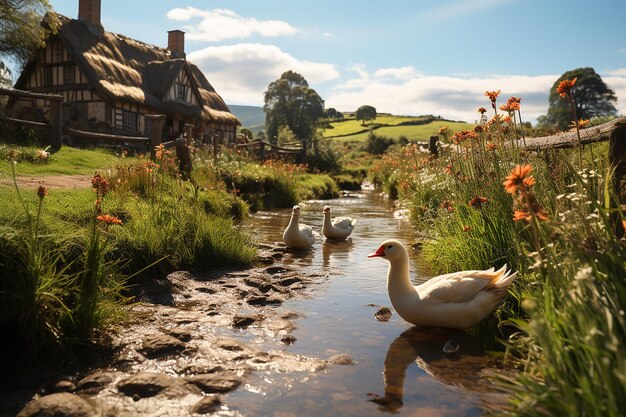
[324, 116, 474, 142]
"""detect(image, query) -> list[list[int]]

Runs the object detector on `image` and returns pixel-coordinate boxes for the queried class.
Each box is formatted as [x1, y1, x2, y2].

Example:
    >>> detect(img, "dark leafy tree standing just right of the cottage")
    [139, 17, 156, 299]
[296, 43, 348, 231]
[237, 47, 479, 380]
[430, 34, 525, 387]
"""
[263, 71, 324, 143]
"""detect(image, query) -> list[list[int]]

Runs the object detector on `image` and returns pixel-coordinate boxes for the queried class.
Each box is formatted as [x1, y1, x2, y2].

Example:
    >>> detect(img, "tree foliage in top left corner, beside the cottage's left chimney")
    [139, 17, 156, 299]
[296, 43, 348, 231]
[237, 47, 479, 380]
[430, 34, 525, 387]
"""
[0, 0, 59, 66]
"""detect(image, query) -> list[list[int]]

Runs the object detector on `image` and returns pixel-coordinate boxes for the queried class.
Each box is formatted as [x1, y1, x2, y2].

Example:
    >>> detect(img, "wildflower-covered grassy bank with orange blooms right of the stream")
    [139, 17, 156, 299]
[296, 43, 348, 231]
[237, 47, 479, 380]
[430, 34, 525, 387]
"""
[370, 97, 626, 416]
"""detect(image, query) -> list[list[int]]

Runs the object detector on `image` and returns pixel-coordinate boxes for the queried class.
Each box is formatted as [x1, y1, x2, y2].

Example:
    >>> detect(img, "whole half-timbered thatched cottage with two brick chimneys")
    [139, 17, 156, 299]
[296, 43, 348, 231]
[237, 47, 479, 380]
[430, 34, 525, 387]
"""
[12, 0, 240, 141]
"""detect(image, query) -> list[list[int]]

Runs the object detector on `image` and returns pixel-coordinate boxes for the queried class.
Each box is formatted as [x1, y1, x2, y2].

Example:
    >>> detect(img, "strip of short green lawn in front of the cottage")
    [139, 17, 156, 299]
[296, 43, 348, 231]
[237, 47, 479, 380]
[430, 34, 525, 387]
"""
[0, 145, 131, 177]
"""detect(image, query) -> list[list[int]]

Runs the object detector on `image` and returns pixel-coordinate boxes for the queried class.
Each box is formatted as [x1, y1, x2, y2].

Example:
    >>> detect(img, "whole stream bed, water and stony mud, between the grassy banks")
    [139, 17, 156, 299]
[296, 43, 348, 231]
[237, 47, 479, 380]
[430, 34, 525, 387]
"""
[0, 191, 506, 417]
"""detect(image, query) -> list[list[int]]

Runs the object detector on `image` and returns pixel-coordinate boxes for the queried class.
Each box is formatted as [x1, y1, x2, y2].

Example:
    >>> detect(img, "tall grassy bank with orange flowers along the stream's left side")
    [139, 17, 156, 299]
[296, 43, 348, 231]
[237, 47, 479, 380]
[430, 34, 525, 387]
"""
[0, 148, 256, 360]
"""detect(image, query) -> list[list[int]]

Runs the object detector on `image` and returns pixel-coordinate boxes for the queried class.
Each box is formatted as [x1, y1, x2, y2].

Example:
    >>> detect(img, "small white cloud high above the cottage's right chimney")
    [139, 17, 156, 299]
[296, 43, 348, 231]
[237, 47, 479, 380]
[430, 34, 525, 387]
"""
[167, 6, 297, 42]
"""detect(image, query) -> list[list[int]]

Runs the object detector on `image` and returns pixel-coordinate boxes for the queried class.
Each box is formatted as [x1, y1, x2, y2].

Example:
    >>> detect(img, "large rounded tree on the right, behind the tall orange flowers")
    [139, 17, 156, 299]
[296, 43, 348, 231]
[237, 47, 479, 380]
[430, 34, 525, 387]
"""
[538, 67, 617, 130]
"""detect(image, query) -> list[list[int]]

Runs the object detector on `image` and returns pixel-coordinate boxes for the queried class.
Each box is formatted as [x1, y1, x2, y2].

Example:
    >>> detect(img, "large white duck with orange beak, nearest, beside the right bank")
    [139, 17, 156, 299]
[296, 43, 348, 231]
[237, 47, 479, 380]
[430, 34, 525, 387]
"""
[368, 240, 517, 329]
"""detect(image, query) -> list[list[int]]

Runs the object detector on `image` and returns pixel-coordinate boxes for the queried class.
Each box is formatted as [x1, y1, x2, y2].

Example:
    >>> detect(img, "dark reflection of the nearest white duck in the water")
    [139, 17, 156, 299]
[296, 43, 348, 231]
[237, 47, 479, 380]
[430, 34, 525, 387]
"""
[369, 327, 488, 414]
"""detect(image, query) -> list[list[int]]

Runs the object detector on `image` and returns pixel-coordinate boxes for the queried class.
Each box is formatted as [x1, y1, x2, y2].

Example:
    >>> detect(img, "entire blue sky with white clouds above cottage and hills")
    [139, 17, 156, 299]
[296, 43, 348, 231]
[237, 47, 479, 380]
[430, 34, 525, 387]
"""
[50, 0, 626, 122]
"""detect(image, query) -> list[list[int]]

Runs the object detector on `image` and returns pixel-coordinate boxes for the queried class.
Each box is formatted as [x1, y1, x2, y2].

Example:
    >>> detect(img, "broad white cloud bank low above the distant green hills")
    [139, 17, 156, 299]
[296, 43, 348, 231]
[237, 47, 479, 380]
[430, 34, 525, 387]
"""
[325, 66, 559, 122]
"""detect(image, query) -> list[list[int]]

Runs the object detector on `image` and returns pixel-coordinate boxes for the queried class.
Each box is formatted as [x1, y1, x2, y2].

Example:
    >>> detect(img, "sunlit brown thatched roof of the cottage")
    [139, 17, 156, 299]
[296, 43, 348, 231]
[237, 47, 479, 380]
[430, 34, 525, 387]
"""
[18, 15, 241, 125]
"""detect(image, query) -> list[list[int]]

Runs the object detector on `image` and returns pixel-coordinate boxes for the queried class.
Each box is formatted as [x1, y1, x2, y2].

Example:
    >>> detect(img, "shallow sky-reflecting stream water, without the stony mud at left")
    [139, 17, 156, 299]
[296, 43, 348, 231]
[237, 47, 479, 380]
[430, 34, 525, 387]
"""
[227, 191, 500, 416]
